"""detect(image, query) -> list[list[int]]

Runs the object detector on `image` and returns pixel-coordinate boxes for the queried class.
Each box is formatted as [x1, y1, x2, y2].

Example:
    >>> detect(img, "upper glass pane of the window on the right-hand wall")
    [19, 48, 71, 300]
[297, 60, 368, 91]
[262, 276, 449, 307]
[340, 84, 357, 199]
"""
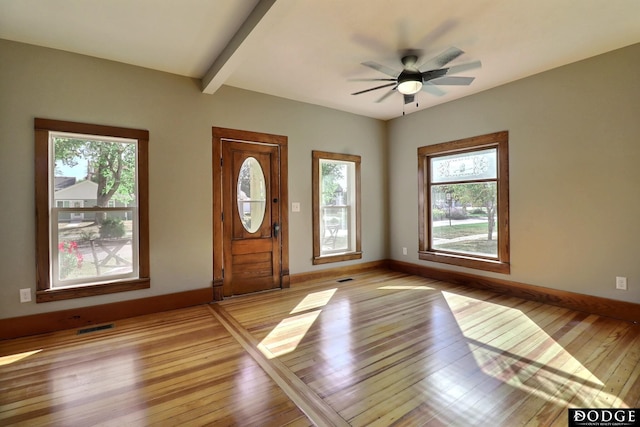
[431, 148, 498, 183]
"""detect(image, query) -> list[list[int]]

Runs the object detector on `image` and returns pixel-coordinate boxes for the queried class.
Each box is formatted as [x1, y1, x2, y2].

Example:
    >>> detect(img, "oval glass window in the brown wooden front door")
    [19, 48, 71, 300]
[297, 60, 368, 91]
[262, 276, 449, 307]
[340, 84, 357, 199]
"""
[237, 157, 266, 233]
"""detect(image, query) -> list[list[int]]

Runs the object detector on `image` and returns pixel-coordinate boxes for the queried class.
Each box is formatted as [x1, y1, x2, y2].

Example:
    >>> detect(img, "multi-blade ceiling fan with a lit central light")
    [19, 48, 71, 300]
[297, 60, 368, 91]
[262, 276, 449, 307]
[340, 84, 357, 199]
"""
[351, 47, 482, 104]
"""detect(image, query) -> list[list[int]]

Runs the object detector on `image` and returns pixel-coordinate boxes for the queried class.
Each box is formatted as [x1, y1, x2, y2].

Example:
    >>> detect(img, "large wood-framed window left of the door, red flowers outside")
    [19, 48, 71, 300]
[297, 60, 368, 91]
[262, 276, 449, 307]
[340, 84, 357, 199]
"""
[35, 119, 150, 302]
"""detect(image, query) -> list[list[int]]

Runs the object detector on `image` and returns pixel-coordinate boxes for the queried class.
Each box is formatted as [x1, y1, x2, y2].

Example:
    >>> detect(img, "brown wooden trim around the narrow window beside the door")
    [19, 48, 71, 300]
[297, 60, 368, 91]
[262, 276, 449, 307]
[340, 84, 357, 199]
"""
[311, 150, 362, 265]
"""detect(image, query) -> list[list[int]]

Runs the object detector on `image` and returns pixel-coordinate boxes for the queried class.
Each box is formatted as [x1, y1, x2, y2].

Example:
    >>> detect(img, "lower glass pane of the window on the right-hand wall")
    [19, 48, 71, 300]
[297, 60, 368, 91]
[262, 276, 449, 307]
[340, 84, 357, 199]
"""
[431, 182, 498, 258]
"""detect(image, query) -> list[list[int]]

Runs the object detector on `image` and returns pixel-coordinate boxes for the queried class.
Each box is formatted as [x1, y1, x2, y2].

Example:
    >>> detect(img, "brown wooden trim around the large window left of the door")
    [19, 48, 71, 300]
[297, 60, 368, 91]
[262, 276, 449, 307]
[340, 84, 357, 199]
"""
[34, 118, 151, 303]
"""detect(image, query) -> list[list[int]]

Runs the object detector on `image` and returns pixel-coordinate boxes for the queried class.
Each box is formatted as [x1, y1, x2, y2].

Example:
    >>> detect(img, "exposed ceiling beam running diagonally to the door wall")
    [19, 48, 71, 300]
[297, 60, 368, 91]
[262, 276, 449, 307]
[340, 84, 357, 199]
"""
[201, 0, 286, 94]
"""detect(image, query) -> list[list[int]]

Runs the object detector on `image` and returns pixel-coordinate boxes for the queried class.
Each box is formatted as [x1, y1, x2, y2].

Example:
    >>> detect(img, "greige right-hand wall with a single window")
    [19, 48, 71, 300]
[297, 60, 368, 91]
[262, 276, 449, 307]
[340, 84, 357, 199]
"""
[388, 44, 640, 303]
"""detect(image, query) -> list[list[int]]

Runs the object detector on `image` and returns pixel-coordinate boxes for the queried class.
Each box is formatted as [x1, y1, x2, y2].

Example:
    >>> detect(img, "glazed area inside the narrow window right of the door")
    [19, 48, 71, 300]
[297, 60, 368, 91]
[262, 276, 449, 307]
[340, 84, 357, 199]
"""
[320, 159, 355, 255]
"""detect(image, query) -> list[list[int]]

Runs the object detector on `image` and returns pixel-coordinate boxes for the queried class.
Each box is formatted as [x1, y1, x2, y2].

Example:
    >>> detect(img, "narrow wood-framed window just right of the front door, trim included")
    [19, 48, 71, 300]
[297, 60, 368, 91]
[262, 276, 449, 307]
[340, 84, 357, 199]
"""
[312, 151, 362, 264]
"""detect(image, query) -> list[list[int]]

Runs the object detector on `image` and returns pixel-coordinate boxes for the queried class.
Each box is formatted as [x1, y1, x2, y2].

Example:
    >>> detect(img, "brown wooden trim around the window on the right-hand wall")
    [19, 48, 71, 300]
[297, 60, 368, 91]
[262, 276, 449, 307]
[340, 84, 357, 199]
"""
[418, 131, 511, 274]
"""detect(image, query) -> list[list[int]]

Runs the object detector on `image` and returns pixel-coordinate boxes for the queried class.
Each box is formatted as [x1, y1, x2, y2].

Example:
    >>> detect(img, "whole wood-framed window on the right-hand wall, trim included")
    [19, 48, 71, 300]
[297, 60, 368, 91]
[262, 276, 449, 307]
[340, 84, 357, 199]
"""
[418, 131, 510, 273]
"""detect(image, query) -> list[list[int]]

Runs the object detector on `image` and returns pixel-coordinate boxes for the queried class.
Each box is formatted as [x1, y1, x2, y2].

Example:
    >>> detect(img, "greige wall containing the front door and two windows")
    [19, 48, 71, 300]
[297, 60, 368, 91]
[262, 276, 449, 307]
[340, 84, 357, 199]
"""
[0, 40, 388, 318]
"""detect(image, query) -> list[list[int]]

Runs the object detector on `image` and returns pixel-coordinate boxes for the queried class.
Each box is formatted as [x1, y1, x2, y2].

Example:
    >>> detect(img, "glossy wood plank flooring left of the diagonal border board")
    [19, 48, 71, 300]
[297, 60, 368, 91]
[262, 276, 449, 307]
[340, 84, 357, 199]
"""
[0, 306, 312, 426]
